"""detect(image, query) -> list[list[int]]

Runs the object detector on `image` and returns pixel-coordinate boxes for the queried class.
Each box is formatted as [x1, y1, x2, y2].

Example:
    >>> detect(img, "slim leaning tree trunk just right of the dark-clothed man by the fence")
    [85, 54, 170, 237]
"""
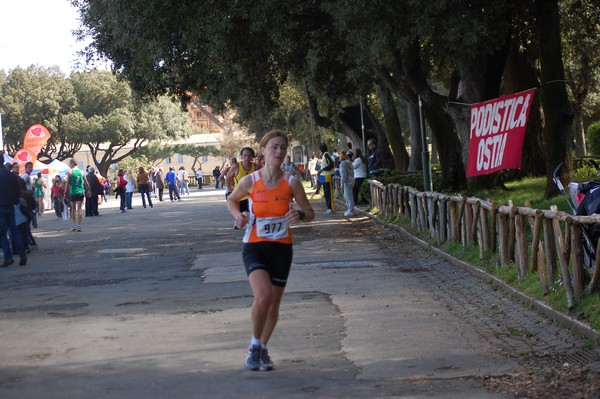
[375, 84, 409, 172]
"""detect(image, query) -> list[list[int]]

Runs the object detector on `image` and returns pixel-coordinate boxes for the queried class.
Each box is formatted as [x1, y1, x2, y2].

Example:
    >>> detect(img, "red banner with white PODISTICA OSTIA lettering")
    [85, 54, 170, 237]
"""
[467, 89, 536, 177]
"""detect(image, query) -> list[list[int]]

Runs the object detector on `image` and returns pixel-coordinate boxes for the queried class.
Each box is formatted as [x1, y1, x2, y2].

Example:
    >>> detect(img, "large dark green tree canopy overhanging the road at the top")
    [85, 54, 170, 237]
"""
[72, 0, 597, 195]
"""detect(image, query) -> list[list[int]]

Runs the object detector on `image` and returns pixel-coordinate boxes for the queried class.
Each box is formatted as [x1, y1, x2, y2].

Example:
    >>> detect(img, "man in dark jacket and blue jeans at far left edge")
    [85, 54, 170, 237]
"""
[0, 151, 27, 267]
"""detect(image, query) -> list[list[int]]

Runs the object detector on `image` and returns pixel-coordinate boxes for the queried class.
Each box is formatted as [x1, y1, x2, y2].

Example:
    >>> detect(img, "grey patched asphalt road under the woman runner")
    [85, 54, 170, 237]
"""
[0, 189, 597, 398]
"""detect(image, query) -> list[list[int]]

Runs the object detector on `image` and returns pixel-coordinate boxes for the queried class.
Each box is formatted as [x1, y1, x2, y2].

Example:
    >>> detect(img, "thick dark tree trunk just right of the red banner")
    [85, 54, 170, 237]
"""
[536, 0, 573, 198]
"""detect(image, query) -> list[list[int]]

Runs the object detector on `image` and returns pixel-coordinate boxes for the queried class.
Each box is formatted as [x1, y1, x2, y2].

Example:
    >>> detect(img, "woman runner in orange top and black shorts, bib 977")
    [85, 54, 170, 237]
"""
[227, 130, 315, 371]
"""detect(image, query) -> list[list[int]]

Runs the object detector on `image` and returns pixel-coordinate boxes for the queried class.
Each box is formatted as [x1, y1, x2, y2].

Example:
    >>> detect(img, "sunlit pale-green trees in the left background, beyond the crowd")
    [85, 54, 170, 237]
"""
[0, 66, 192, 175]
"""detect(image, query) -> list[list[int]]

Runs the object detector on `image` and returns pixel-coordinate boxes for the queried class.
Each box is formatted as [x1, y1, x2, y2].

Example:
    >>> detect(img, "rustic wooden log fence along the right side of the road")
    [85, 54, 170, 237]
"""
[368, 180, 600, 309]
